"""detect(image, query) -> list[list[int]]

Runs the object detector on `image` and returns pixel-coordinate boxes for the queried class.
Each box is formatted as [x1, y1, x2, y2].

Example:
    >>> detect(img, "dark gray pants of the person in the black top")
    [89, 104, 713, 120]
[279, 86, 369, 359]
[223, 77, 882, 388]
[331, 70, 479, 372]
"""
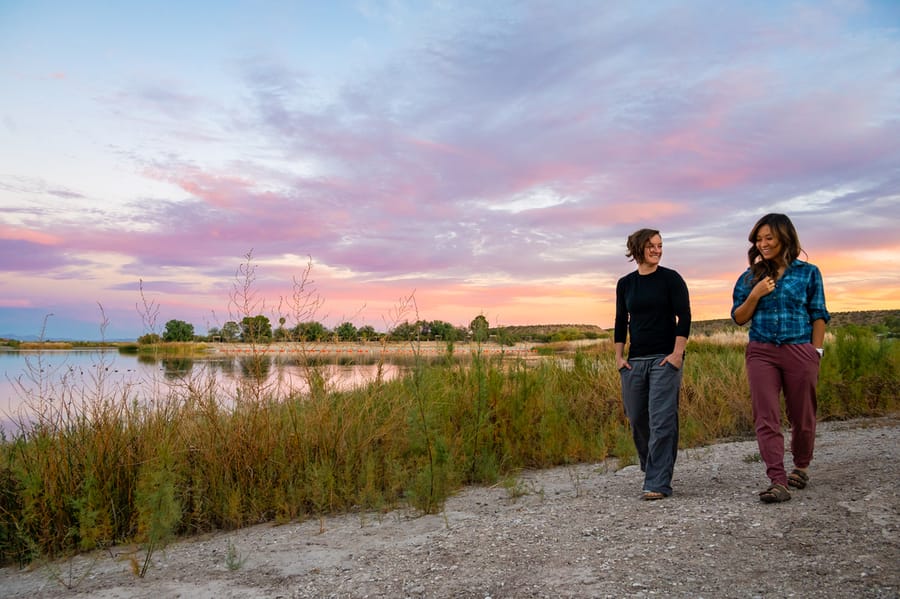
[619, 355, 682, 495]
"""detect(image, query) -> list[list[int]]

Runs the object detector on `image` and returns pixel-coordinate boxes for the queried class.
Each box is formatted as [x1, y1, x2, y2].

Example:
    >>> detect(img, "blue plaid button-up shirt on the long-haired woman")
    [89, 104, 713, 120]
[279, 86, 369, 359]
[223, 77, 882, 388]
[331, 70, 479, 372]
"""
[731, 260, 831, 345]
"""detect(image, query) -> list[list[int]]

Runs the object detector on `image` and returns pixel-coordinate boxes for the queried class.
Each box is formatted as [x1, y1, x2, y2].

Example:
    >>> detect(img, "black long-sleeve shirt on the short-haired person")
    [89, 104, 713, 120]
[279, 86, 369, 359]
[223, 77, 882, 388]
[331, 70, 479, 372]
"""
[614, 266, 691, 358]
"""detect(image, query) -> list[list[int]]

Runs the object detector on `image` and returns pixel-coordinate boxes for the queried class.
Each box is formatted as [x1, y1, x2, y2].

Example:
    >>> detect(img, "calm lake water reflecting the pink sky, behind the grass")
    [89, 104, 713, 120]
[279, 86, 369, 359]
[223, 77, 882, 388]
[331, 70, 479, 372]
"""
[0, 350, 399, 433]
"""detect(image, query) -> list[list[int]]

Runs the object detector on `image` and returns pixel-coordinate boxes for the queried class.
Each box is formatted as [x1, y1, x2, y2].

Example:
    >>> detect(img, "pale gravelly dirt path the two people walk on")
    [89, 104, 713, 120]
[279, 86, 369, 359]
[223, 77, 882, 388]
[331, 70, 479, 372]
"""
[0, 417, 900, 599]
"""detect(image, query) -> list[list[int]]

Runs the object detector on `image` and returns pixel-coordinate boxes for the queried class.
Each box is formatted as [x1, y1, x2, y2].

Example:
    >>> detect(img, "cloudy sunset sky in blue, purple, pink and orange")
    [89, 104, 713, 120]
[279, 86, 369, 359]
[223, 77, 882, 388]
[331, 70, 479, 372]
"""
[0, 0, 900, 339]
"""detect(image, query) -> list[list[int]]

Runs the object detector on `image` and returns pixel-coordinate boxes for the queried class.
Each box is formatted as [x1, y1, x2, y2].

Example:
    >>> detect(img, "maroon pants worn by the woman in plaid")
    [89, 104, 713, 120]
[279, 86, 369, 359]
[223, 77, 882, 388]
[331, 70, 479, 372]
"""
[746, 341, 820, 485]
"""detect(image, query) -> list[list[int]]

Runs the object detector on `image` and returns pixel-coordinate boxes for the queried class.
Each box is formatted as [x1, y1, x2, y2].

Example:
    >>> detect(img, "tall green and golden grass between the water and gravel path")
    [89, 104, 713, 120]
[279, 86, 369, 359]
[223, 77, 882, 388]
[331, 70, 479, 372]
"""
[0, 338, 898, 574]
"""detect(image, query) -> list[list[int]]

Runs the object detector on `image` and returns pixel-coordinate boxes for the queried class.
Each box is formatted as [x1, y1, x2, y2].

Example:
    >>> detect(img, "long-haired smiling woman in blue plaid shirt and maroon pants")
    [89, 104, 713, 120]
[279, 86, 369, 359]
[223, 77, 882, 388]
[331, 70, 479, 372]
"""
[731, 214, 831, 503]
